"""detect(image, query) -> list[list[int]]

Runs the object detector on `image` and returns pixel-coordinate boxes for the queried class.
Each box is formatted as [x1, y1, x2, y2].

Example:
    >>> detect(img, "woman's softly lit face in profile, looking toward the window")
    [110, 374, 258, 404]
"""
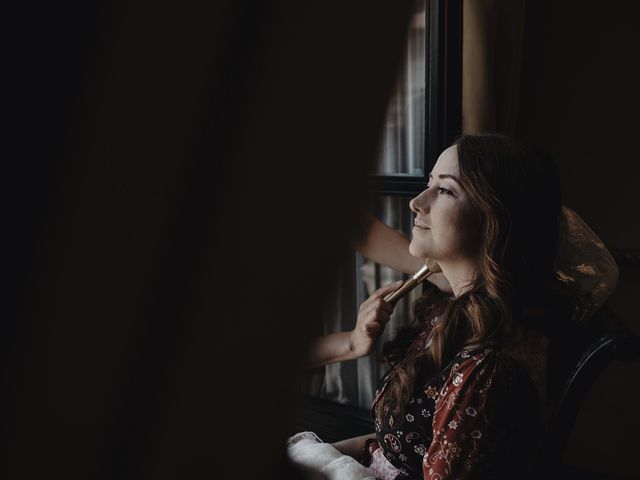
[409, 146, 480, 262]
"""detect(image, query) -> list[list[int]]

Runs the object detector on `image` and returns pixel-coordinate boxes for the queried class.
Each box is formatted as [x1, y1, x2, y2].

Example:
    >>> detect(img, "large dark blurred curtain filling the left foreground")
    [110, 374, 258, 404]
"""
[0, 0, 411, 479]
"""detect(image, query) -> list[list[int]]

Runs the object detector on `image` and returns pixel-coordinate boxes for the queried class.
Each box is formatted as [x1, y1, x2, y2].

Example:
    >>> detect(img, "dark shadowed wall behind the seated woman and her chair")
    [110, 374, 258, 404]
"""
[518, 0, 640, 478]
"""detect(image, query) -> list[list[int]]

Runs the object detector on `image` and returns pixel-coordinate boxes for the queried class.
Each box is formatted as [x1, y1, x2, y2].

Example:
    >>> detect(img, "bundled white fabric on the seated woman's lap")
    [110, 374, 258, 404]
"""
[287, 432, 376, 480]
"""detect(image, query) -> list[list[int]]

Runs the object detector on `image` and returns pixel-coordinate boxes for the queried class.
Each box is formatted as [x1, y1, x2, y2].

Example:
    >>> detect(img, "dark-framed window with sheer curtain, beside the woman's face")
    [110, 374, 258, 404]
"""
[309, 0, 462, 408]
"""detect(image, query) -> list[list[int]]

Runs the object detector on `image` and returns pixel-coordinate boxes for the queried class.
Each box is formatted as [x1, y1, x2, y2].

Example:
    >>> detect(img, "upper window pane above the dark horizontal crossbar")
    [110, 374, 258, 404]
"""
[375, 0, 427, 176]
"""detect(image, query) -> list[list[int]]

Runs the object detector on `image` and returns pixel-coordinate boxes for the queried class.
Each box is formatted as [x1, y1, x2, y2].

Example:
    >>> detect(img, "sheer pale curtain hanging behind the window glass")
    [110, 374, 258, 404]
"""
[310, 0, 428, 408]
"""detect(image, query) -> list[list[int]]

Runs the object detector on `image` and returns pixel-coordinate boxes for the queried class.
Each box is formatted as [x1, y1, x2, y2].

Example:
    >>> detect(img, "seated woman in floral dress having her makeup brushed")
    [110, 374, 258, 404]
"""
[334, 134, 561, 479]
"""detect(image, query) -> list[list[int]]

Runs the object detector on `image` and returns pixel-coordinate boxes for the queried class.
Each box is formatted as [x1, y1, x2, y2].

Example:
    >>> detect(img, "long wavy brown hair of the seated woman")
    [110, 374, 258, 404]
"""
[376, 134, 561, 417]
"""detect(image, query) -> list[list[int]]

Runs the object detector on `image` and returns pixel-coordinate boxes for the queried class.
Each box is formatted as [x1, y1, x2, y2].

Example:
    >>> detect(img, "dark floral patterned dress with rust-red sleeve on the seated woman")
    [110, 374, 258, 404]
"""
[374, 346, 542, 480]
